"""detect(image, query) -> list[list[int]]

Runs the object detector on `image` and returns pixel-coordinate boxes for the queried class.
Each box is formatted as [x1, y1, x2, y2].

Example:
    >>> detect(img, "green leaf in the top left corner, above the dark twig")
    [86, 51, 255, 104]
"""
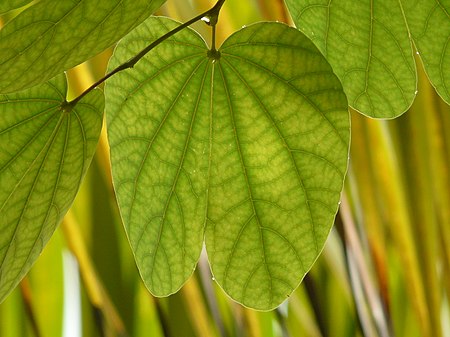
[0, 0, 164, 93]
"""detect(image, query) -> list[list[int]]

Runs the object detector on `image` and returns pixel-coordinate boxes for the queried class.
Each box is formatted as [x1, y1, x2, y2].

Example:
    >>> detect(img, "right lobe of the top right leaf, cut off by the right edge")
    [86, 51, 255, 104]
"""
[403, 0, 450, 104]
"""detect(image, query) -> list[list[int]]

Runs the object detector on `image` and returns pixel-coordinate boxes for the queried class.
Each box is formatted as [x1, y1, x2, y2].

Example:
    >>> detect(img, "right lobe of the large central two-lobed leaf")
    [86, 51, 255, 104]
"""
[206, 23, 349, 309]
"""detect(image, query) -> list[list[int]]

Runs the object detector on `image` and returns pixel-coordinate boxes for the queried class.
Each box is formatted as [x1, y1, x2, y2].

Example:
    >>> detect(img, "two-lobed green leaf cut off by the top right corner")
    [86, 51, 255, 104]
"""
[286, 0, 450, 118]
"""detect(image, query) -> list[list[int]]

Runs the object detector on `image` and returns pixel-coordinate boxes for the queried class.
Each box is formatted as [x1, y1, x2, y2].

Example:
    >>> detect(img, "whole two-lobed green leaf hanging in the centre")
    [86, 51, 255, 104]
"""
[106, 18, 349, 310]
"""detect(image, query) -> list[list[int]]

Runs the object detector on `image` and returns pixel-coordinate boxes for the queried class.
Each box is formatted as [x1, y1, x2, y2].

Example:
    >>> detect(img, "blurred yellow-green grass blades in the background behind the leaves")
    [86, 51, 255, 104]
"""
[0, 0, 450, 337]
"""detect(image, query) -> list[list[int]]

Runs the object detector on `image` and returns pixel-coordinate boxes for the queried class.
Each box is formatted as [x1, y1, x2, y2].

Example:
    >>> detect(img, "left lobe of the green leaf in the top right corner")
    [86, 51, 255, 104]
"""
[286, 0, 417, 118]
